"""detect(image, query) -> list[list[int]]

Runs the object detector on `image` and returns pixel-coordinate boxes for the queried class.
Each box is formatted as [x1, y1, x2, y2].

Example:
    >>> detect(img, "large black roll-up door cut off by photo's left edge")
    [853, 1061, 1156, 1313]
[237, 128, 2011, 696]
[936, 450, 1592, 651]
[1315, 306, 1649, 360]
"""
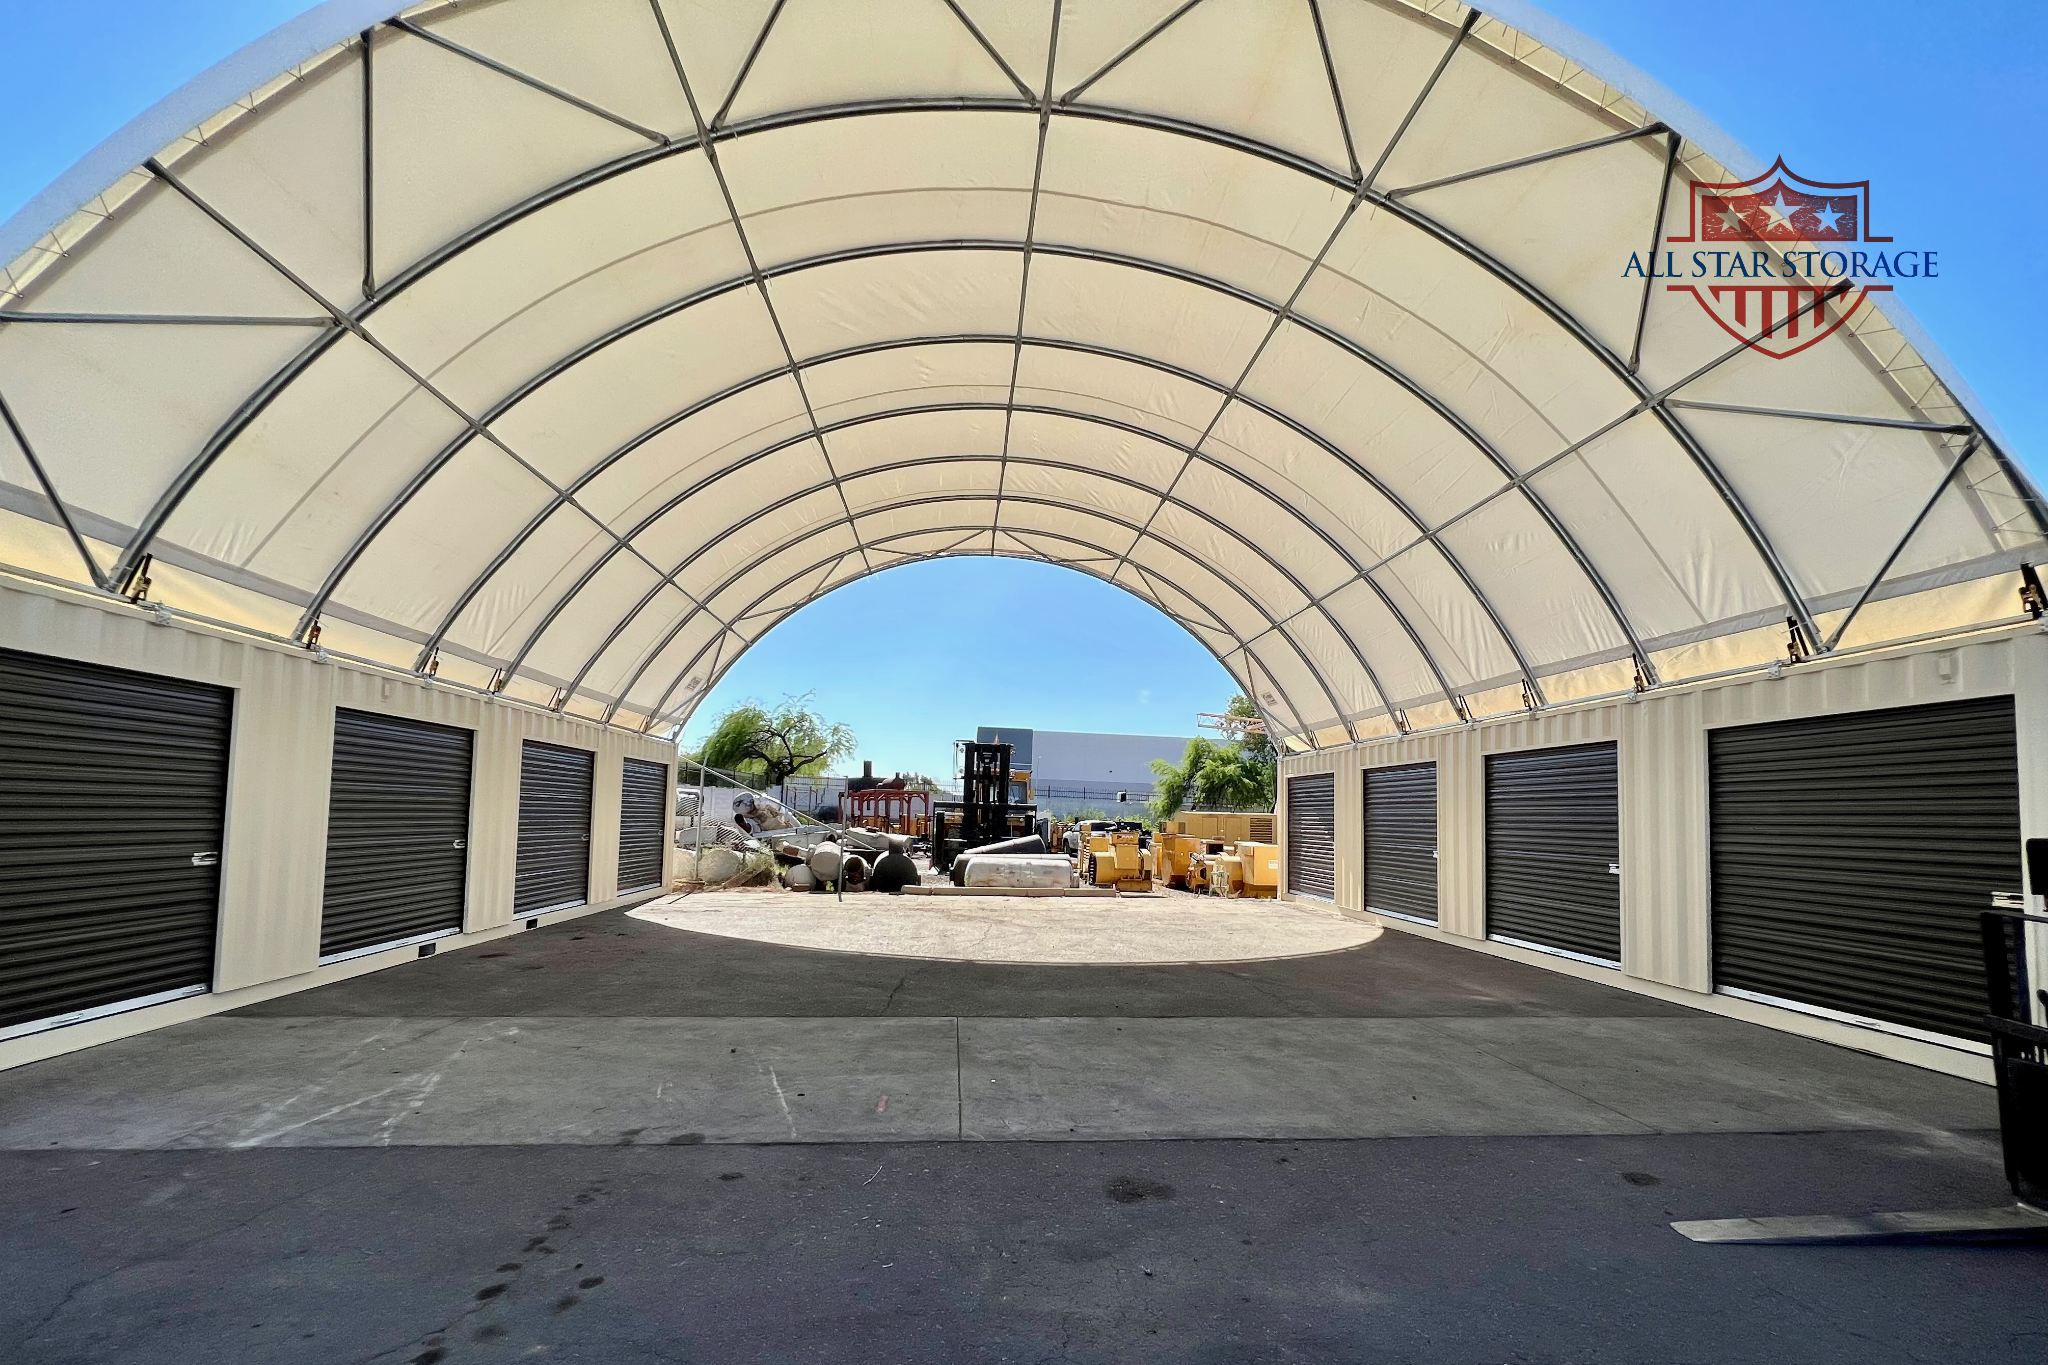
[0, 649, 233, 1029]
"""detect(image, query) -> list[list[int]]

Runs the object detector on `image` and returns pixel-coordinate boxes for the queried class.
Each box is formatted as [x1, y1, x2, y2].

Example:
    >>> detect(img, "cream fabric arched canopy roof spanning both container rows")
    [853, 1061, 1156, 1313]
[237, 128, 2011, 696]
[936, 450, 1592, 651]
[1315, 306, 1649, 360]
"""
[0, 0, 2048, 747]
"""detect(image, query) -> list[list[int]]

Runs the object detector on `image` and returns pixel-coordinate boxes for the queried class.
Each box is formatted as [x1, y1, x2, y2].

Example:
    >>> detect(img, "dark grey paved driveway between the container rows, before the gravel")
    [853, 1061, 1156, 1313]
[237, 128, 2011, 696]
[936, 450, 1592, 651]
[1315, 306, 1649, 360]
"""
[0, 913, 2048, 1365]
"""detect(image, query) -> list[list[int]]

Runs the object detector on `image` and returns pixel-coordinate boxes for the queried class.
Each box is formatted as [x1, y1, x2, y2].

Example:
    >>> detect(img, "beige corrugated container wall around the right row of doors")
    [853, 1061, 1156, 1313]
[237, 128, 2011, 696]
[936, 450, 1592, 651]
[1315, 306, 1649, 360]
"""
[1280, 626, 2048, 1081]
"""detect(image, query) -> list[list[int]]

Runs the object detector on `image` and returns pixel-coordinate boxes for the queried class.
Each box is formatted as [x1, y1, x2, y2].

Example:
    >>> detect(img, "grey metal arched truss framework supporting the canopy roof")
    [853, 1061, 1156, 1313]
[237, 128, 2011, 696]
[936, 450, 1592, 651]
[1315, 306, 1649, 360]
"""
[0, 0, 2048, 743]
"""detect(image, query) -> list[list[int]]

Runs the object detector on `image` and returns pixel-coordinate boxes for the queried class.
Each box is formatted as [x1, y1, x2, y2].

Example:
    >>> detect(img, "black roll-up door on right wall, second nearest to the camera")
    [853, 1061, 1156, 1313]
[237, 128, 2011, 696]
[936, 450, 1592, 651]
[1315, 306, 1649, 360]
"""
[1487, 745, 1622, 962]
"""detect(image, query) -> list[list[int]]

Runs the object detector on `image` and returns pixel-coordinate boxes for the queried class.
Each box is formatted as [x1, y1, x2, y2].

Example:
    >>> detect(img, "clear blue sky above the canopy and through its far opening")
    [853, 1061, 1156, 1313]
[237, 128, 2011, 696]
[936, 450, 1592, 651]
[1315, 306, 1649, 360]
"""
[0, 0, 2048, 772]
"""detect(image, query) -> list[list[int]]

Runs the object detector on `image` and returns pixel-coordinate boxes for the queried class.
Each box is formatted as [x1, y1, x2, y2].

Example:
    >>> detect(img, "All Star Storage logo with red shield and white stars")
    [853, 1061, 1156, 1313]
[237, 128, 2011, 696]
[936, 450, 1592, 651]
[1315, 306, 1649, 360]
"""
[1622, 158, 1939, 358]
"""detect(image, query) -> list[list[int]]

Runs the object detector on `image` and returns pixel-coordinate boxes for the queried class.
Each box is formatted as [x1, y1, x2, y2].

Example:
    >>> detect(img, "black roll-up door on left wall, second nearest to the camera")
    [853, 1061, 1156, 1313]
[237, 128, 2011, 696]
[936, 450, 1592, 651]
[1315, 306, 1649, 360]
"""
[319, 708, 473, 958]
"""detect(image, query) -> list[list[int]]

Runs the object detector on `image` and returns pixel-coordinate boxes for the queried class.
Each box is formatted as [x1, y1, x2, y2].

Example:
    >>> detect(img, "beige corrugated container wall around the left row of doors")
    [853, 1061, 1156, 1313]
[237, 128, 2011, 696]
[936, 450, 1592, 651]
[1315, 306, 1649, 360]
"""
[0, 583, 674, 1066]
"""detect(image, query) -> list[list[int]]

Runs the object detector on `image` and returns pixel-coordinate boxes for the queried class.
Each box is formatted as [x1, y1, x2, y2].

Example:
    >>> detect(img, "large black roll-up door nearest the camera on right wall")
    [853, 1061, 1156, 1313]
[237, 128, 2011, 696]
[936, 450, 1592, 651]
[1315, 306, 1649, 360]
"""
[1708, 696, 2021, 1040]
